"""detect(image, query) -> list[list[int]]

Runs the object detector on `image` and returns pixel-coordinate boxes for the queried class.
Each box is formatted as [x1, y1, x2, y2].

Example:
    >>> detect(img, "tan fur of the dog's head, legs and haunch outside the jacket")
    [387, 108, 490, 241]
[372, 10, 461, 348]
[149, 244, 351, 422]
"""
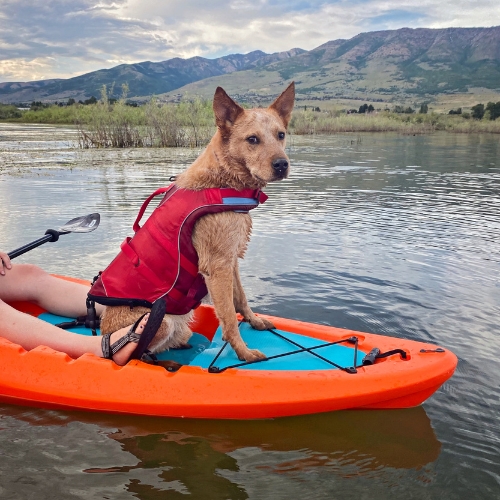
[101, 83, 295, 361]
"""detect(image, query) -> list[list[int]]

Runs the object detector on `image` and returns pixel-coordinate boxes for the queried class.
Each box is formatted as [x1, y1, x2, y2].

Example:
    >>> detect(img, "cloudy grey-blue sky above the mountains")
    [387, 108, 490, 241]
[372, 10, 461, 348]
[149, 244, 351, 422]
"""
[0, 0, 500, 82]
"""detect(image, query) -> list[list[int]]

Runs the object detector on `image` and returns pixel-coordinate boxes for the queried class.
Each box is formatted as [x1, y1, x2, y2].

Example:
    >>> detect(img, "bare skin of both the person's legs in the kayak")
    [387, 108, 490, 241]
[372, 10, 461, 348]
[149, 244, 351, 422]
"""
[0, 261, 149, 365]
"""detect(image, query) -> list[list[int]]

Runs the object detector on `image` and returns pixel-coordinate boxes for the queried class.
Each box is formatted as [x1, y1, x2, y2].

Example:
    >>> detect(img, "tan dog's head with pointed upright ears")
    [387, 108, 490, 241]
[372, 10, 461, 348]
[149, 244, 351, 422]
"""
[213, 82, 295, 187]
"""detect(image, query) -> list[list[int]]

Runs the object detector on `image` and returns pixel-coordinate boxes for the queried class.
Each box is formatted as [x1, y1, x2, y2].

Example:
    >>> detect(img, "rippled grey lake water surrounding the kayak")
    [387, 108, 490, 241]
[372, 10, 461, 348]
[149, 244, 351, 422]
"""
[0, 124, 500, 500]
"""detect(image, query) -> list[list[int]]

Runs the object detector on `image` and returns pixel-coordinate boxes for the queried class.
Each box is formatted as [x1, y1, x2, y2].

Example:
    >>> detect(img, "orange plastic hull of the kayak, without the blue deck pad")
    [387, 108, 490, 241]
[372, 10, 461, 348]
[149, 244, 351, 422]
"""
[0, 278, 457, 419]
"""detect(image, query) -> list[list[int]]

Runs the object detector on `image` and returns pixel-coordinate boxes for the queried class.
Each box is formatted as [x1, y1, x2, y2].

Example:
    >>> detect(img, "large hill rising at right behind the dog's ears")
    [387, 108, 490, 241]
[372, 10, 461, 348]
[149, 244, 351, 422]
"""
[156, 27, 500, 106]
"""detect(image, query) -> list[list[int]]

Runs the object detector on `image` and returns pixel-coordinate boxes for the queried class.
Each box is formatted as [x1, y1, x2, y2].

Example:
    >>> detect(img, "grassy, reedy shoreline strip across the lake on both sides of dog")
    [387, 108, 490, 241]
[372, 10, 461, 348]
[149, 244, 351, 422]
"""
[0, 105, 500, 149]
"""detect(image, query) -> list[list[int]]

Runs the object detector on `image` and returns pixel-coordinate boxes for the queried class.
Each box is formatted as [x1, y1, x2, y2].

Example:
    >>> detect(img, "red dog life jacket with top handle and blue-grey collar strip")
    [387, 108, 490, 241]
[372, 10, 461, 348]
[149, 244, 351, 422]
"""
[88, 184, 267, 314]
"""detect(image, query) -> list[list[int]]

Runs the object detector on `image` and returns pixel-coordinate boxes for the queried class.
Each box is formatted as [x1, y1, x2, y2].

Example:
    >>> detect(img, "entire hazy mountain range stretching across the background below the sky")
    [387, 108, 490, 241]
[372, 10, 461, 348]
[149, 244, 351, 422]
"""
[0, 26, 500, 103]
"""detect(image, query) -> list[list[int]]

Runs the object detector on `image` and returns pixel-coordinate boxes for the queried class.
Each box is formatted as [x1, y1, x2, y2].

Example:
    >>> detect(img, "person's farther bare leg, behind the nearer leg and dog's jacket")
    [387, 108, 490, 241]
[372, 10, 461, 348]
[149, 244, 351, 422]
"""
[0, 264, 103, 318]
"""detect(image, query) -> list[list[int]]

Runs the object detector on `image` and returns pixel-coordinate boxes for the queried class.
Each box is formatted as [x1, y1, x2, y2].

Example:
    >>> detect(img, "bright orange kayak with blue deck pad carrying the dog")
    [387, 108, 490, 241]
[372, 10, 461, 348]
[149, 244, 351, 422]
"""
[0, 278, 457, 419]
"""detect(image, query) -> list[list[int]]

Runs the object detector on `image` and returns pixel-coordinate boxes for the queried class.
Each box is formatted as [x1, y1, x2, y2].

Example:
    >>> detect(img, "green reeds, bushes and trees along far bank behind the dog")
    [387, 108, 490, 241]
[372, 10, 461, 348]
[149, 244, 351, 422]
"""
[0, 85, 500, 148]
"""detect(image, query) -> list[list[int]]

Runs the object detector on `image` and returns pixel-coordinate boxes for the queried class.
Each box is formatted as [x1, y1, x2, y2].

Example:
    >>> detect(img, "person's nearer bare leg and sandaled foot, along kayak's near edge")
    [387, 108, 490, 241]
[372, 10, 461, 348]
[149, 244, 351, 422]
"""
[0, 296, 149, 365]
